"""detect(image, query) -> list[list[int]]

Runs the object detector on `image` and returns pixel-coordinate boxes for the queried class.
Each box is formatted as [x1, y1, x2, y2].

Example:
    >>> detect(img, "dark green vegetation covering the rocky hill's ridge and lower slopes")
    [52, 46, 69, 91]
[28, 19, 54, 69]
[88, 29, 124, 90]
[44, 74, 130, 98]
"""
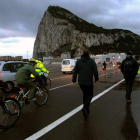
[48, 6, 140, 56]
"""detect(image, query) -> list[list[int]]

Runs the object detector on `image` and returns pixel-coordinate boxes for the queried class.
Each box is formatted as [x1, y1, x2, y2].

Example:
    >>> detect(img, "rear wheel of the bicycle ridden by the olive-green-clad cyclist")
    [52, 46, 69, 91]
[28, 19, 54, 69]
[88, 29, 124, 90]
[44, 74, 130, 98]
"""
[5, 92, 25, 109]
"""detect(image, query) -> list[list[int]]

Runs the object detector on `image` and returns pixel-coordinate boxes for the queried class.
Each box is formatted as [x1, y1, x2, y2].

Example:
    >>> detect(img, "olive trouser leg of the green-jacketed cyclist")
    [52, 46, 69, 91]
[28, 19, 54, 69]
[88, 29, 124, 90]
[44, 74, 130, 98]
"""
[25, 82, 35, 100]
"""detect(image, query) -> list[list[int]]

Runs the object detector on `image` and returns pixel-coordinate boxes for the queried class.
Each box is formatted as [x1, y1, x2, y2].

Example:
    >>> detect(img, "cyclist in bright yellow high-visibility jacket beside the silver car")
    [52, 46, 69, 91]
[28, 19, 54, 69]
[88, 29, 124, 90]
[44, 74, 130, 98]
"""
[31, 58, 49, 84]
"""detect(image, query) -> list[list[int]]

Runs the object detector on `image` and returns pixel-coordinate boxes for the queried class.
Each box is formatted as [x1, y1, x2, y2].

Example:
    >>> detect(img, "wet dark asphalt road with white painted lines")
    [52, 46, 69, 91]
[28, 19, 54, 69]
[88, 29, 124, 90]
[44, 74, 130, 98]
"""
[0, 65, 140, 140]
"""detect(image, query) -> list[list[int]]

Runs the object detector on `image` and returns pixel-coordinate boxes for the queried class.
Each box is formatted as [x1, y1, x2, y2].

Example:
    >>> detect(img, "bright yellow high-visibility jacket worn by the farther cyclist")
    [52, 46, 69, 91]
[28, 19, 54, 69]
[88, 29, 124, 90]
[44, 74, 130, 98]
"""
[31, 60, 49, 78]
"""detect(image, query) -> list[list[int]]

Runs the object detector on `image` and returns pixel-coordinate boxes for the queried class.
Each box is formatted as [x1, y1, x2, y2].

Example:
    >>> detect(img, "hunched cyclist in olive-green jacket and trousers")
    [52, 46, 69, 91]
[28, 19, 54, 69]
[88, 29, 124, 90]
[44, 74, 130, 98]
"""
[15, 58, 42, 101]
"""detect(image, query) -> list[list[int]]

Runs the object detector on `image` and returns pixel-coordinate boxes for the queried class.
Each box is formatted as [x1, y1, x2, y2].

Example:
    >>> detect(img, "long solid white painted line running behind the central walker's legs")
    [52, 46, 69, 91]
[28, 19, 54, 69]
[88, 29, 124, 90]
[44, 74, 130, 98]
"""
[25, 79, 124, 140]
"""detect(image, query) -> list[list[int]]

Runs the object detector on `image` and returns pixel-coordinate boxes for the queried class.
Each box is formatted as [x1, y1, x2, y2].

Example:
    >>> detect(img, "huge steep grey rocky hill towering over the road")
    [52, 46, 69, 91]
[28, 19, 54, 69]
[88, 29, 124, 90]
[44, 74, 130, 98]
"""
[33, 6, 140, 58]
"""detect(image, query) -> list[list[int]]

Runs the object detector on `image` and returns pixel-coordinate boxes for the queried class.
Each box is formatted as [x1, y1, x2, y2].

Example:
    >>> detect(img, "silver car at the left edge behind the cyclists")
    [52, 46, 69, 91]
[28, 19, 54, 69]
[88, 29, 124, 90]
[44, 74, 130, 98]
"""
[0, 61, 27, 92]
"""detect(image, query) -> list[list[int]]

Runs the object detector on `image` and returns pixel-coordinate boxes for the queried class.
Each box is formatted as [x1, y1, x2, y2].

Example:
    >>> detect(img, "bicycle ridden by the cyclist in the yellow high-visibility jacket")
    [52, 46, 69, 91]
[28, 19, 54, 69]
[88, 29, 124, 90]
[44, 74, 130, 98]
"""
[41, 72, 52, 90]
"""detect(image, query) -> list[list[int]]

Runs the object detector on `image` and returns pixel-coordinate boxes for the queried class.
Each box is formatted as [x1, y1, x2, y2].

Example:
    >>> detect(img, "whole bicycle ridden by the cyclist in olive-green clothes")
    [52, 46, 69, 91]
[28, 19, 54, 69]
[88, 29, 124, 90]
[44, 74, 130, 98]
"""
[5, 79, 49, 108]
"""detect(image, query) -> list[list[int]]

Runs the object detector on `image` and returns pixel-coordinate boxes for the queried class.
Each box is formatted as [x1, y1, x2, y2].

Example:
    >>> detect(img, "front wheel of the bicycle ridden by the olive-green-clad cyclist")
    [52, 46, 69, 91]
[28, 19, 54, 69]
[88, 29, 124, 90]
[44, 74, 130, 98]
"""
[35, 87, 49, 106]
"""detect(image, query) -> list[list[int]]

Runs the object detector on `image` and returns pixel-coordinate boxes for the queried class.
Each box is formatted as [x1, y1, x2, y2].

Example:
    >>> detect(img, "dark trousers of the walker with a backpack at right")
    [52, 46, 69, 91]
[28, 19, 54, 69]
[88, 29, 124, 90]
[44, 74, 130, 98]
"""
[124, 76, 135, 100]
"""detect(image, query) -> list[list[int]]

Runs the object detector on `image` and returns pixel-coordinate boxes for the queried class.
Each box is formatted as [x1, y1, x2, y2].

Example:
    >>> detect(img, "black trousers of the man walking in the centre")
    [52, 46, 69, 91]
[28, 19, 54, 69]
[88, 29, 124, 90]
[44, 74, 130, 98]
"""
[80, 85, 94, 110]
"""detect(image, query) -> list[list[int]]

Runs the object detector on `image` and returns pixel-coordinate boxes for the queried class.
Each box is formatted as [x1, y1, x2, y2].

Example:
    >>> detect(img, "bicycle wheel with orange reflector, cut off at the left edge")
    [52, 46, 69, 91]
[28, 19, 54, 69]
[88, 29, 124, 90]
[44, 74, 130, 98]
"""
[0, 98, 21, 129]
